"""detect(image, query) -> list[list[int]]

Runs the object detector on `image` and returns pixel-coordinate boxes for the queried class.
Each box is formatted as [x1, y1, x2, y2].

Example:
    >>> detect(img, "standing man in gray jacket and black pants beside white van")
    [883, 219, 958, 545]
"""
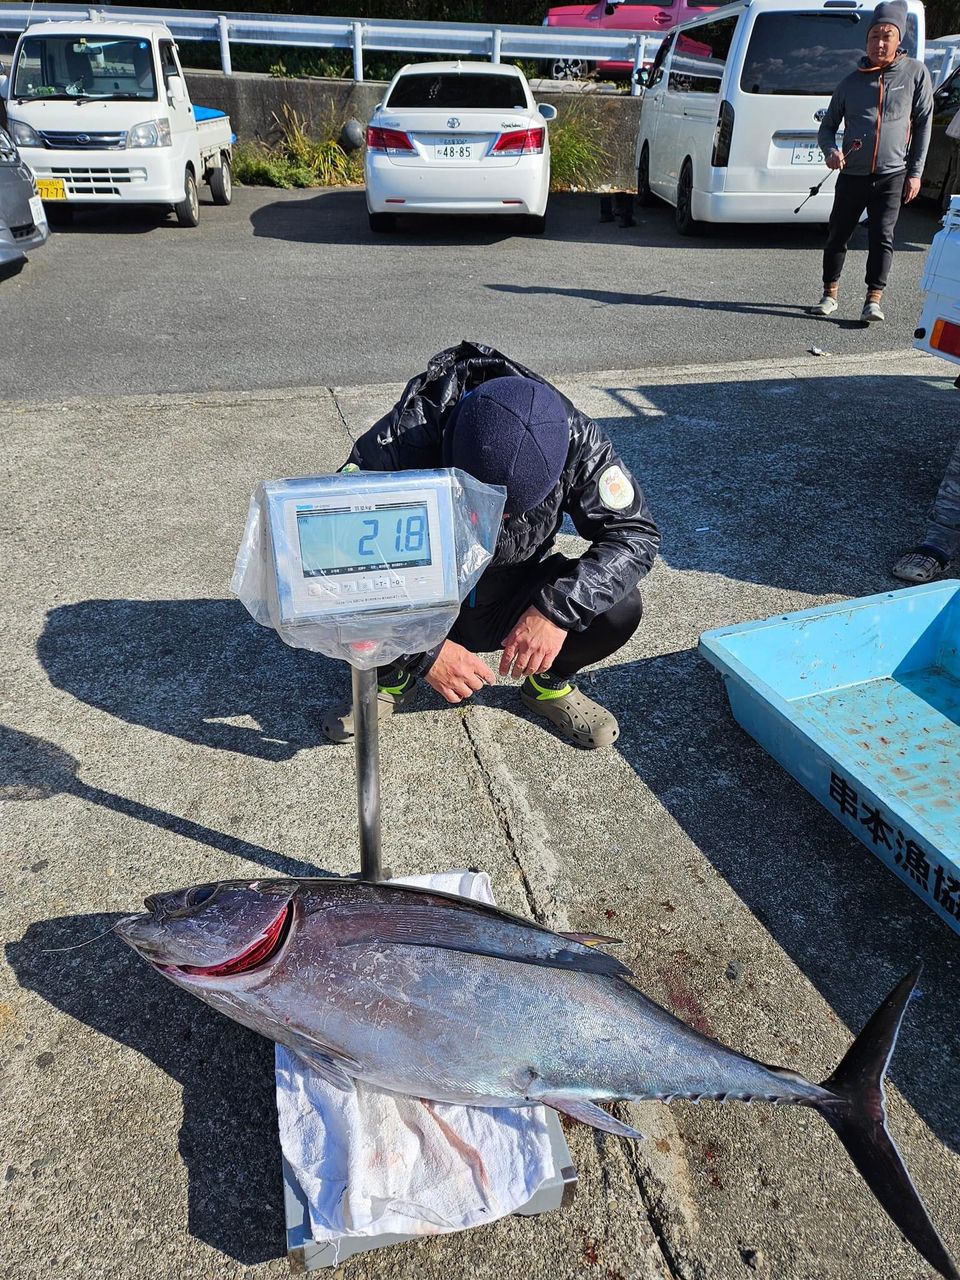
[813, 0, 933, 324]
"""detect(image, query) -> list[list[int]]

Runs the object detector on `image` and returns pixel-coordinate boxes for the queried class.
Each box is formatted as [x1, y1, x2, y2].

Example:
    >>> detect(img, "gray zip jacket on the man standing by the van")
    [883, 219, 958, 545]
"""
[817, 54, 933, 178]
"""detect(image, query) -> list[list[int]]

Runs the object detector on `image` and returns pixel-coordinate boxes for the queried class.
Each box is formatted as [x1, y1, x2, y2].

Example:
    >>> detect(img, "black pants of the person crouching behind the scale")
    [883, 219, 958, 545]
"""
[378, 554, 644, 685]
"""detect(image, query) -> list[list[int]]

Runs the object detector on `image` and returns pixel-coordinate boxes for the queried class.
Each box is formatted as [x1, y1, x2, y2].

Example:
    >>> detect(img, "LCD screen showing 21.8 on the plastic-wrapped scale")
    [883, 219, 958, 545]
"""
[297, 503, 431, 577]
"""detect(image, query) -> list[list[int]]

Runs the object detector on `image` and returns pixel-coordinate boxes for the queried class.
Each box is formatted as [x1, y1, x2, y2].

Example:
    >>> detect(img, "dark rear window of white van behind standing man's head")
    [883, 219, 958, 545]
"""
[740, 13, 916, 96]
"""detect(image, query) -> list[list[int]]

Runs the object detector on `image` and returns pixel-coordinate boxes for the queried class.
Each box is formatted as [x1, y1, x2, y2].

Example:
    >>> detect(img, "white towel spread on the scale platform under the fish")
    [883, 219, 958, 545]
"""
[276, 872, 557, 1240]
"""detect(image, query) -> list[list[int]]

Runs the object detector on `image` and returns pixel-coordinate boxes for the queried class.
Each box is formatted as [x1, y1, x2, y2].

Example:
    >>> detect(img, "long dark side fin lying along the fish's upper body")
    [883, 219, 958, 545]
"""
[324, 883, 632, 978]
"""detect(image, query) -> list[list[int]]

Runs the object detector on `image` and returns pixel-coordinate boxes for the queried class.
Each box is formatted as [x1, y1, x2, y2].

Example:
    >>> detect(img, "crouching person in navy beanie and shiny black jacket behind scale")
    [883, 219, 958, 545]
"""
[323, 342, 660, 748]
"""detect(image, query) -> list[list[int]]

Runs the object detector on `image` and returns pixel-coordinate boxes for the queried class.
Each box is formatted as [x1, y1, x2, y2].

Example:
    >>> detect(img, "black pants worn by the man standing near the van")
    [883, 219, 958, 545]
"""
[823, 169, 906, 289]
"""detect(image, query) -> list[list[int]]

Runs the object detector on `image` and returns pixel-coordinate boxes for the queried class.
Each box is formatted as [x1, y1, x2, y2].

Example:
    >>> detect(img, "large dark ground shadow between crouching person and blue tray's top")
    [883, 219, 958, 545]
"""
[600, 371, 960, 599]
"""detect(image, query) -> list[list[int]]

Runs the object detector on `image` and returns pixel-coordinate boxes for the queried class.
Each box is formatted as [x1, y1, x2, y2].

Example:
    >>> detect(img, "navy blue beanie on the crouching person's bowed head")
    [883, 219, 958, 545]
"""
[448, 376, 570, 516]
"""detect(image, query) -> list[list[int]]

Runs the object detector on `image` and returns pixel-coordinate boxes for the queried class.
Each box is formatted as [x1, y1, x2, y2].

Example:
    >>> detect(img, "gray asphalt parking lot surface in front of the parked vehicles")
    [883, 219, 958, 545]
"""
[0, 188, 937, 399]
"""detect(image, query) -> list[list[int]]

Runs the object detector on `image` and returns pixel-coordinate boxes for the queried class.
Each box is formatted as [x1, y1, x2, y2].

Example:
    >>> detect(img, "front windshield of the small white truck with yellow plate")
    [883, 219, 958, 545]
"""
[13, 36, 156, 101]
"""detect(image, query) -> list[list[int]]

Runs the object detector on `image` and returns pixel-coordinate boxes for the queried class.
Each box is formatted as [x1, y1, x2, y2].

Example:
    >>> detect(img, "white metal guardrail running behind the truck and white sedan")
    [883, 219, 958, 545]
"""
[0, 4, 663, 93]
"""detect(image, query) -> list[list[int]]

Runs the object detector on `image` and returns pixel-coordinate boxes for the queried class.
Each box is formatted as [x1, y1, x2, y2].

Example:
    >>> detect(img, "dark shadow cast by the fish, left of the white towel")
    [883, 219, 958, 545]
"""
[5, 915, 285, 1263]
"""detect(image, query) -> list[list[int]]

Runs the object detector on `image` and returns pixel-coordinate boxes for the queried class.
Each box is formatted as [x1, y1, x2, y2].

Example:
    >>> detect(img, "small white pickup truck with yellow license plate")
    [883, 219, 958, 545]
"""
[0, 12, 234, 227]
